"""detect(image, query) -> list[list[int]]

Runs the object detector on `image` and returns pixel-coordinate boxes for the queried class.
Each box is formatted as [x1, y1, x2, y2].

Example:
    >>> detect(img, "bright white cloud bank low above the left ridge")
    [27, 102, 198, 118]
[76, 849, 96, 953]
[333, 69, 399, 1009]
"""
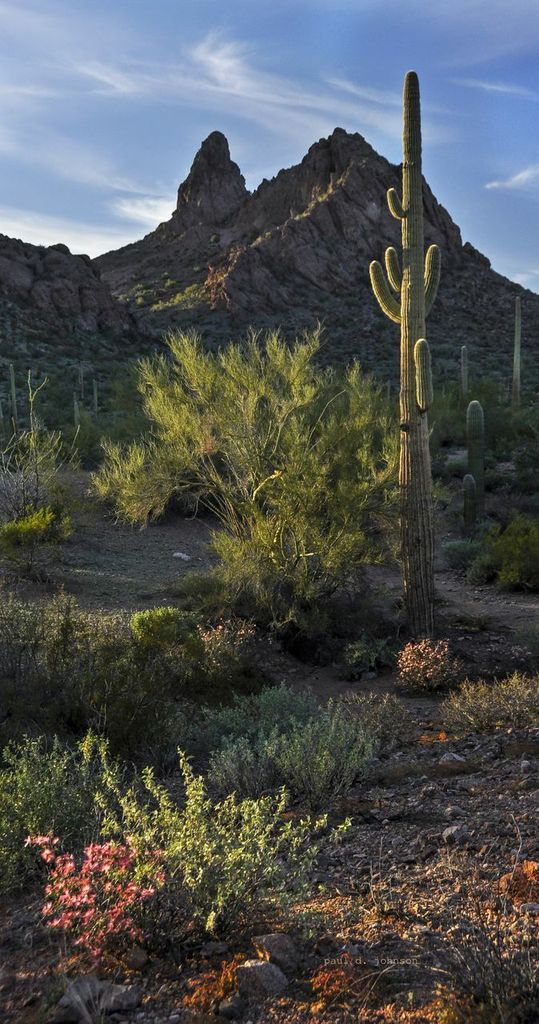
[0, 207, 137, 257]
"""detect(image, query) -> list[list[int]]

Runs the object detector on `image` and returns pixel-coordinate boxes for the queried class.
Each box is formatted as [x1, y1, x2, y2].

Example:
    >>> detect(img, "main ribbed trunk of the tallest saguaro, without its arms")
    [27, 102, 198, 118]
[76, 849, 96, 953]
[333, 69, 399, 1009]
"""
[399, 72, 433, 636]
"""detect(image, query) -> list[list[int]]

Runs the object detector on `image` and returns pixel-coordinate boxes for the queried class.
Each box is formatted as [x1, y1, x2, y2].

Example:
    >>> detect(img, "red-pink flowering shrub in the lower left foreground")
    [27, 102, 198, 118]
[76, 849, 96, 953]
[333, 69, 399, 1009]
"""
[27, 836, 164, 961]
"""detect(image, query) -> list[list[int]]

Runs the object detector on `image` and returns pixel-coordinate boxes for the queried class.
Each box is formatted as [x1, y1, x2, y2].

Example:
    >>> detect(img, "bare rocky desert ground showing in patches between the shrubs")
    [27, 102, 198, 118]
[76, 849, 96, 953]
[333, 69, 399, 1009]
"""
[0, 475, 539, 1024]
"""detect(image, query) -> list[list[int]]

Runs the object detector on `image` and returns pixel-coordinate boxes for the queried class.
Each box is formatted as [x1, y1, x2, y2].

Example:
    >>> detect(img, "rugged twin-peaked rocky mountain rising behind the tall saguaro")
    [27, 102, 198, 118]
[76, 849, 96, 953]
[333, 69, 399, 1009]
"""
[95, 128, 539, 385]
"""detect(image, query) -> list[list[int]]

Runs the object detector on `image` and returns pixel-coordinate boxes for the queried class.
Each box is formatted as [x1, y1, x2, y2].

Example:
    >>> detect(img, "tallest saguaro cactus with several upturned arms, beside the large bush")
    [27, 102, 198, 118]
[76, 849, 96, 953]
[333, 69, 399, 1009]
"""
[370, 71, 441, 637]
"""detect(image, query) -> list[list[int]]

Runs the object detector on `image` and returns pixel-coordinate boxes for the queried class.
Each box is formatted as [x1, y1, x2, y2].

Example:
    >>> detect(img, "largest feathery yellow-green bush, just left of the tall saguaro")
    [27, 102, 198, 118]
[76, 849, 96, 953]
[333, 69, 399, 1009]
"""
[94, 333, 398, 625]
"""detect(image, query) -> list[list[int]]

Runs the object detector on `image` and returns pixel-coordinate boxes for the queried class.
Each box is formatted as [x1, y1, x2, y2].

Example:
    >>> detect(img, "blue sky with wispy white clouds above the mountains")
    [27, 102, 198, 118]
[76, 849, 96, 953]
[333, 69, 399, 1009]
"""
[0, 0, 539, 292]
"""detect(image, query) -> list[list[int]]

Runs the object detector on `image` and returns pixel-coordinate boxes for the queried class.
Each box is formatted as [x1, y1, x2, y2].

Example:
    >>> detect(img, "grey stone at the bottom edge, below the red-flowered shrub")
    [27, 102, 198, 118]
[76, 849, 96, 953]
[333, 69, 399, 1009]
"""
[50, 975, 142, 1024]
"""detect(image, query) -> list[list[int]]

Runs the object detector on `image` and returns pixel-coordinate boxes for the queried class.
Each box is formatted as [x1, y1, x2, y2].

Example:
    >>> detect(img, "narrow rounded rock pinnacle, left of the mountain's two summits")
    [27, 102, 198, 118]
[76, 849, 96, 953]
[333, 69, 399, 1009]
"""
[173, 131, 249, 231]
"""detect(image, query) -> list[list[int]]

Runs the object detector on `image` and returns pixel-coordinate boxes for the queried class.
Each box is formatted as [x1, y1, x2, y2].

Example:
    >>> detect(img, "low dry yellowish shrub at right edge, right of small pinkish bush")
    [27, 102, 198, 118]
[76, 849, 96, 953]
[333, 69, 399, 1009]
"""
[442, 672, 539, 732]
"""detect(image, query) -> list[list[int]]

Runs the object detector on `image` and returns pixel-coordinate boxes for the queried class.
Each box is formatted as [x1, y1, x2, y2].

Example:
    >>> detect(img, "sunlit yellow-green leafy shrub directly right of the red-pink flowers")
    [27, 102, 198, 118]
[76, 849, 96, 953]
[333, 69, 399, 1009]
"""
[101, 755, 329, 944]
